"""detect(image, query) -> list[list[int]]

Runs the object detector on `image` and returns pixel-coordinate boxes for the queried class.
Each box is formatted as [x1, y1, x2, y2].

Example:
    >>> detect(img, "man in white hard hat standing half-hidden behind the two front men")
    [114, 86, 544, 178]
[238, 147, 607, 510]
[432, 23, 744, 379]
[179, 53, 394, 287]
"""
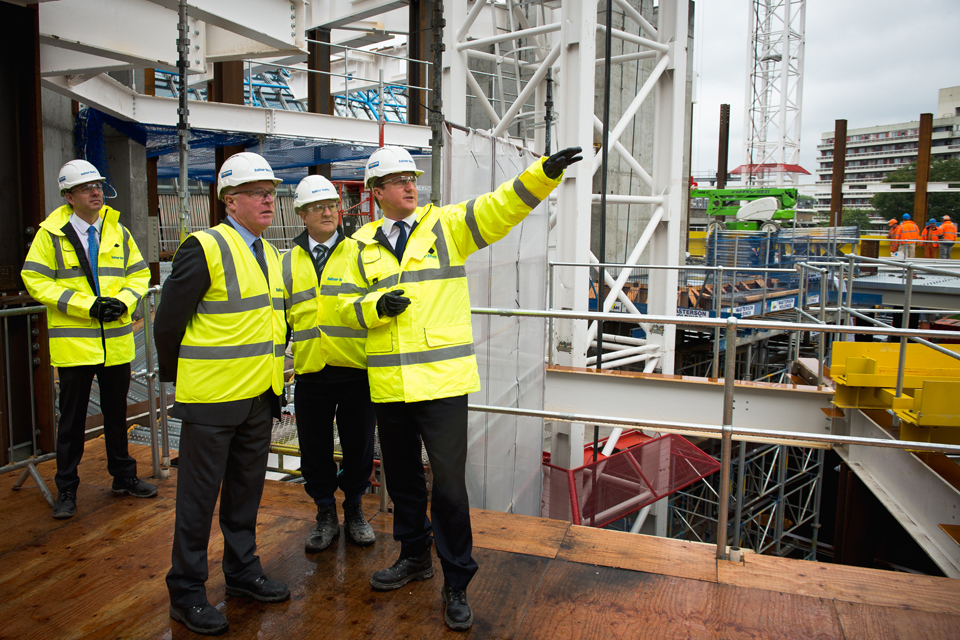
[281, 176, 377, 553]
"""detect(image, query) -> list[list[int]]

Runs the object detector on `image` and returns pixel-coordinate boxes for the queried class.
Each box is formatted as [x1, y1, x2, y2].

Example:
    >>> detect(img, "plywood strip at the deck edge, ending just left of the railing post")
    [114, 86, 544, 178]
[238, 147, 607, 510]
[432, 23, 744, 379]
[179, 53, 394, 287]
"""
[557, 525, 717, 582]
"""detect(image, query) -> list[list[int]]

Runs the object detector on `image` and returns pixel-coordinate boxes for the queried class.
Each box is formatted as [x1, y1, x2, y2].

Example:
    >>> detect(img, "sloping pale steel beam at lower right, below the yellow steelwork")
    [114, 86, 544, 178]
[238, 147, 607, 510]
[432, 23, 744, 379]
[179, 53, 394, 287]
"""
[835, 410, 960, 578]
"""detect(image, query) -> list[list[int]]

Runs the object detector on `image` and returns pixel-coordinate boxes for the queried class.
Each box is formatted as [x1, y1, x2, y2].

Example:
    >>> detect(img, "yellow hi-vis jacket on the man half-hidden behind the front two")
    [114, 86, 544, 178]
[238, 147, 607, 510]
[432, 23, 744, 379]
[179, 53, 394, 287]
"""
[281, 229, 367, 375]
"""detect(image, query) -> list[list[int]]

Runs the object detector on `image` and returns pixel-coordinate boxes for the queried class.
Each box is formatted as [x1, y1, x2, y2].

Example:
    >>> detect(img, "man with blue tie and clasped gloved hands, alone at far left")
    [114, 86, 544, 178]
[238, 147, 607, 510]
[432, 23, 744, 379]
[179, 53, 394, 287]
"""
[21, 160, 157, 519]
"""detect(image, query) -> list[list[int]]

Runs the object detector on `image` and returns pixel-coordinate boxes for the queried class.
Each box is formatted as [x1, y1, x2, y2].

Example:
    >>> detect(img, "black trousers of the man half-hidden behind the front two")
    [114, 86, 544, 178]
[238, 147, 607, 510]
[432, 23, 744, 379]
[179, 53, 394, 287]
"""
[294, 372, 377, 507]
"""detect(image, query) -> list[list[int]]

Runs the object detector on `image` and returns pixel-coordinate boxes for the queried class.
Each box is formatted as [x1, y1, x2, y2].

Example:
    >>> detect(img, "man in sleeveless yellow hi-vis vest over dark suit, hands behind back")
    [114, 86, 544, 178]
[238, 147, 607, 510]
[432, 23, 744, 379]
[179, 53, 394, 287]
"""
[154, 152, 290, 635]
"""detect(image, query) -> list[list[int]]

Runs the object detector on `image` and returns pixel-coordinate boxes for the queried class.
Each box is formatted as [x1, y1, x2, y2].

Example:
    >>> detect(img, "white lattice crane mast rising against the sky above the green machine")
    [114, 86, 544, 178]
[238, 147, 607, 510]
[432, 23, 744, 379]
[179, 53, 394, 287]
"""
[743, 0, 807, 186]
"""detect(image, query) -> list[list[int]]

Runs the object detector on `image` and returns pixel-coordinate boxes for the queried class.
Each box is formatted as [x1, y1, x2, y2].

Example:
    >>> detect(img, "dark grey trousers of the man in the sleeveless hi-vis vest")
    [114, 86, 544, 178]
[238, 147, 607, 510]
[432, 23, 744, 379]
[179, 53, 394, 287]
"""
[167, 393, 273, 608]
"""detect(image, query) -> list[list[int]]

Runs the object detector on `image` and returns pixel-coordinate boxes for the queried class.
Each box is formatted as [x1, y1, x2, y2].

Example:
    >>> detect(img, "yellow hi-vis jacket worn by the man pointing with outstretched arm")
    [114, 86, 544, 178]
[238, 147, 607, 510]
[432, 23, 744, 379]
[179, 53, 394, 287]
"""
[337, 159, 562, 402]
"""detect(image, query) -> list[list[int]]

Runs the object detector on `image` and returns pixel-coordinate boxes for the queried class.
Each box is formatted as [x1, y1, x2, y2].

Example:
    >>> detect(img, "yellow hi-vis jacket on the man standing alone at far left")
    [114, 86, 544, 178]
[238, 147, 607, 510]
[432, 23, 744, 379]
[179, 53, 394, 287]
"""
[20, 205, 150, 367]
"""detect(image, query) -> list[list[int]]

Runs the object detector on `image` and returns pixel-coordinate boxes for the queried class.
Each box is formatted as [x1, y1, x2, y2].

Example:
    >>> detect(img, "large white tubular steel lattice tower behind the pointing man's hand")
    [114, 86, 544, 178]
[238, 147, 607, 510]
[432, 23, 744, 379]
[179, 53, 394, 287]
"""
[443, 0, 688, 373]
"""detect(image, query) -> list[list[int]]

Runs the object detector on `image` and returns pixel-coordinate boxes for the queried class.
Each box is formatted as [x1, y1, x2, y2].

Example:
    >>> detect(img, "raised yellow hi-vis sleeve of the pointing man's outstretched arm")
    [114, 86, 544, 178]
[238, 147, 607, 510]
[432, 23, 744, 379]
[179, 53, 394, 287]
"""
[443, 157, 563, 257]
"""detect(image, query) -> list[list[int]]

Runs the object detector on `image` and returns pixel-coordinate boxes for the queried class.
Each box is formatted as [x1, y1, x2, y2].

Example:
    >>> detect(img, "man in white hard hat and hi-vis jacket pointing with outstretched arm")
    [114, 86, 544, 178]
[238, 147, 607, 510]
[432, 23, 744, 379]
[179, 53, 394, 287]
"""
[338, 147, 581, 629]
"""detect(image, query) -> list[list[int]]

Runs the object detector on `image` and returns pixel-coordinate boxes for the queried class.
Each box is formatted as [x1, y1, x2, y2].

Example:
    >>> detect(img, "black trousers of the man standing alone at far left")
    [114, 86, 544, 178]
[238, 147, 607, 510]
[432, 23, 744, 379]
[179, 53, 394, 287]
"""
[56, 363, 137, 493]
